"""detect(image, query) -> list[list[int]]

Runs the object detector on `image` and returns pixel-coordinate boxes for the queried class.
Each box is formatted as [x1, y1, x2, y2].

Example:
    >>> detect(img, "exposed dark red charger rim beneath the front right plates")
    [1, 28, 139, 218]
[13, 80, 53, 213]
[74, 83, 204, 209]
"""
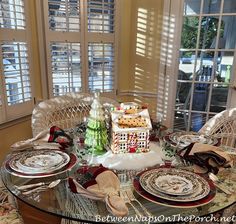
[133, 171, 216, 208]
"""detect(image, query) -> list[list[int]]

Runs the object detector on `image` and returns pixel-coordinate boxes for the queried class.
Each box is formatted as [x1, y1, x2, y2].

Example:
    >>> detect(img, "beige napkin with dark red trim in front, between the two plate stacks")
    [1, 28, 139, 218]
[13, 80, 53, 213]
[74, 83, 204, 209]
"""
[68, 167, 128, 216]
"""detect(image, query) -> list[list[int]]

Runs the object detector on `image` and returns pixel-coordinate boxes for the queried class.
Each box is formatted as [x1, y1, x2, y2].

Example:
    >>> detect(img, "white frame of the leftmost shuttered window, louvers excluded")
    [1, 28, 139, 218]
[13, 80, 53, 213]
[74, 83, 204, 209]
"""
[0, 0, 35, 125]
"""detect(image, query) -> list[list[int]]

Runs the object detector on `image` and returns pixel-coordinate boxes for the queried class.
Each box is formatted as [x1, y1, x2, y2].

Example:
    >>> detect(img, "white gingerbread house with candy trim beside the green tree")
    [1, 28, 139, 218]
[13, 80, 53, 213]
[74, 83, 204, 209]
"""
[111, 102, 152, 153]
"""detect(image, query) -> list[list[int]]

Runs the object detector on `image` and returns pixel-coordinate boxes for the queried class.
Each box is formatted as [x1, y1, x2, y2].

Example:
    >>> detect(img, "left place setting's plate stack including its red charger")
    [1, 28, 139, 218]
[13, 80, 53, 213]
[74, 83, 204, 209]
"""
[5, 149, 76, 178]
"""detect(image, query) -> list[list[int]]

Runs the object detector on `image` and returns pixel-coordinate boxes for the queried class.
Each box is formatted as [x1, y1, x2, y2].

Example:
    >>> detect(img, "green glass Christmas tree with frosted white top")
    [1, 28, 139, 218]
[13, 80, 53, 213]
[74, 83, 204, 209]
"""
[85, 92, 108, 155]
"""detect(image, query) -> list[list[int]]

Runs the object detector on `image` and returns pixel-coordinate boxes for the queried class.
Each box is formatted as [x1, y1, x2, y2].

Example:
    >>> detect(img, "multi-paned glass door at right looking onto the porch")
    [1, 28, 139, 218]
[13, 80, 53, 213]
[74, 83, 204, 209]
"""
[164, 0, 236, 132]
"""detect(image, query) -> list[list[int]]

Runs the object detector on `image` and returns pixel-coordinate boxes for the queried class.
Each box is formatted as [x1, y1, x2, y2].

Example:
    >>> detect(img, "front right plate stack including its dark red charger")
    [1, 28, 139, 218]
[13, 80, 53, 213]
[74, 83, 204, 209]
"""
[134, 168, 215, 208]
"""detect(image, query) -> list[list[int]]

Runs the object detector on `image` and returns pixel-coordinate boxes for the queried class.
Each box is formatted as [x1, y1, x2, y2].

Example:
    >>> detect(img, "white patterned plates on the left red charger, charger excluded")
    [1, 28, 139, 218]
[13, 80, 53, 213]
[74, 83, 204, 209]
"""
[9, 150, 70, 174]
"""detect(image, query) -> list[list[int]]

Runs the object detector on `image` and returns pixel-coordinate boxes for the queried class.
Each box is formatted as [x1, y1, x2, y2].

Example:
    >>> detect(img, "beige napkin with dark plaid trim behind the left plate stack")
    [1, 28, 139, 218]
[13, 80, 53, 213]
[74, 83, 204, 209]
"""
[11, 126, 73, 151]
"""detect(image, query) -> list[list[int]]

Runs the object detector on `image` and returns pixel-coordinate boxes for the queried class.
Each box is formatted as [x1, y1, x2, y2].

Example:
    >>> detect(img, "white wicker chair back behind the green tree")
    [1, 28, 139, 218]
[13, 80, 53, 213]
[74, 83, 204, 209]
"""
[31, 93, 118, 137]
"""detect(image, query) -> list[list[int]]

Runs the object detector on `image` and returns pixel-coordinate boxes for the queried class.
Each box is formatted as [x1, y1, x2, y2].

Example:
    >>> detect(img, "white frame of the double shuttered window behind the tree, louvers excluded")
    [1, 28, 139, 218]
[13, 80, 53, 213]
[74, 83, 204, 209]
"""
[36, 0, 120, 99]
